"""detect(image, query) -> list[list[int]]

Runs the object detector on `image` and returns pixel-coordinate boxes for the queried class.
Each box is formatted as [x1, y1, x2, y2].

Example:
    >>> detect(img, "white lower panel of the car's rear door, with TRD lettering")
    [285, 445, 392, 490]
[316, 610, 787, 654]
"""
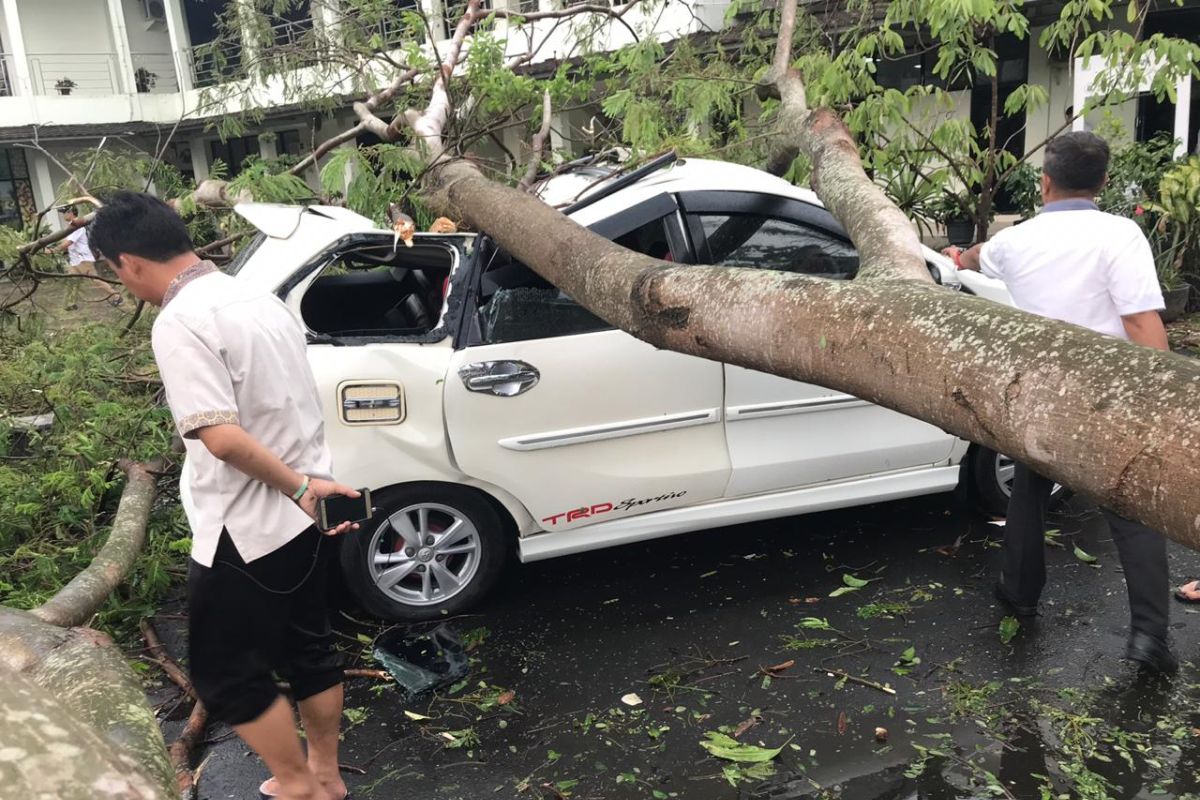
[445, 330, 730, 531]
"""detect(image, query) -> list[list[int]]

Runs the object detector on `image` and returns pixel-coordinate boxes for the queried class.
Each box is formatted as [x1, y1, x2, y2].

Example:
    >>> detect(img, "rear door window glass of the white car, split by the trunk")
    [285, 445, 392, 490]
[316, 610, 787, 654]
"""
[480, 217, 674, 344]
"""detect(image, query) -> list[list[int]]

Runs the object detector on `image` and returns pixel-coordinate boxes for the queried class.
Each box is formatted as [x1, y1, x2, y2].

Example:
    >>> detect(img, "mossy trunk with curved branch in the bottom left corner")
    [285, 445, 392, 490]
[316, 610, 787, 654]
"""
[0, 464, 176, 800]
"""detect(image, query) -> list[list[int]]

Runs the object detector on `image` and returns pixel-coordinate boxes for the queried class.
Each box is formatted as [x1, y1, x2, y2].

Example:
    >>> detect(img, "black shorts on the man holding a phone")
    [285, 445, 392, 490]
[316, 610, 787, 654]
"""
[187, 528, 342, 724]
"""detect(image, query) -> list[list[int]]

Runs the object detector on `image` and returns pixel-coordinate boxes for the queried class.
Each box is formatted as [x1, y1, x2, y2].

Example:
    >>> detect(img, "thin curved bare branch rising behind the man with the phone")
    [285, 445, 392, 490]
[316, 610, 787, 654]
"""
[32, 463, 157, 627]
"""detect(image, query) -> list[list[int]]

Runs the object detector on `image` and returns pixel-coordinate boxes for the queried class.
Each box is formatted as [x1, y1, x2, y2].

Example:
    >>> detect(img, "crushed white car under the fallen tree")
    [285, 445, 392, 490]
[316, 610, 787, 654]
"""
[229, 154, 1036, 620]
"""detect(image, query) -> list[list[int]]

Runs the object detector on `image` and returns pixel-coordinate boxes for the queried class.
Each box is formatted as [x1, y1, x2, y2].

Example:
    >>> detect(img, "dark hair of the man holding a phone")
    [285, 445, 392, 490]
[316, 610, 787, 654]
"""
[88, 192, 194, 261]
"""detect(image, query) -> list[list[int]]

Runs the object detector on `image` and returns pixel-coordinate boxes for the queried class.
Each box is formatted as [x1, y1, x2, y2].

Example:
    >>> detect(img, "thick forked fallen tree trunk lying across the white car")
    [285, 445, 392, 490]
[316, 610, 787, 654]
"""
[431, 140, 1200, 549]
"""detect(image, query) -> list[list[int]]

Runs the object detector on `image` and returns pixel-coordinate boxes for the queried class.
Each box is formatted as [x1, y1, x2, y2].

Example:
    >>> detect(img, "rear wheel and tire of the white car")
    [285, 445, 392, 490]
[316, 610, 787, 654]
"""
[341, 483, 511, 622]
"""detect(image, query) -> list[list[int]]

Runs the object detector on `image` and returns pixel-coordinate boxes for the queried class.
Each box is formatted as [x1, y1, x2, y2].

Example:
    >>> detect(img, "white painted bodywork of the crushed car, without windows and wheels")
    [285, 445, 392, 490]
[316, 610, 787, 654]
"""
[225, 160, 1010, 575]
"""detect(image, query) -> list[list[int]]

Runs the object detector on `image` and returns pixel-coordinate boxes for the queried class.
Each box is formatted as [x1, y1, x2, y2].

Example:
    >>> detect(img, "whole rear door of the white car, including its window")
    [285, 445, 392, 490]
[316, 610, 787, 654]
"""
[444, 203, 730, 530]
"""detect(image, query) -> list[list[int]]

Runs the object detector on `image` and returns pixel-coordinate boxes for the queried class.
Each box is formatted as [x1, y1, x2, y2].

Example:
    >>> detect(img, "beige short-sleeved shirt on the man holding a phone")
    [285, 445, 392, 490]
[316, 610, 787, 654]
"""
[151, 261, 332, 566]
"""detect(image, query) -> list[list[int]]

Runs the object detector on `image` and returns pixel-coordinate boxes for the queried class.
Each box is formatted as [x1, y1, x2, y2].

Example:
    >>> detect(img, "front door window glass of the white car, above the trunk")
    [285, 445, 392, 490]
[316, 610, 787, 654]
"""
[692, 213, 858, 279]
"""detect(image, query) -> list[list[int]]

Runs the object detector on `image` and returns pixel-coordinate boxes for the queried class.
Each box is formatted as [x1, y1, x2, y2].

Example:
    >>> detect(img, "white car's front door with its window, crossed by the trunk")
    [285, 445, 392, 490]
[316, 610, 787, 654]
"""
[679, 192, 955, 497]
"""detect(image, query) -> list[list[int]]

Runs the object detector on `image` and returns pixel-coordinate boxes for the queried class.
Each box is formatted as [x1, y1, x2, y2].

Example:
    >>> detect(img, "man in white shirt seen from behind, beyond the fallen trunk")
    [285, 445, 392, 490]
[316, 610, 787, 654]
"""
[943, 132, 1178, 673]
